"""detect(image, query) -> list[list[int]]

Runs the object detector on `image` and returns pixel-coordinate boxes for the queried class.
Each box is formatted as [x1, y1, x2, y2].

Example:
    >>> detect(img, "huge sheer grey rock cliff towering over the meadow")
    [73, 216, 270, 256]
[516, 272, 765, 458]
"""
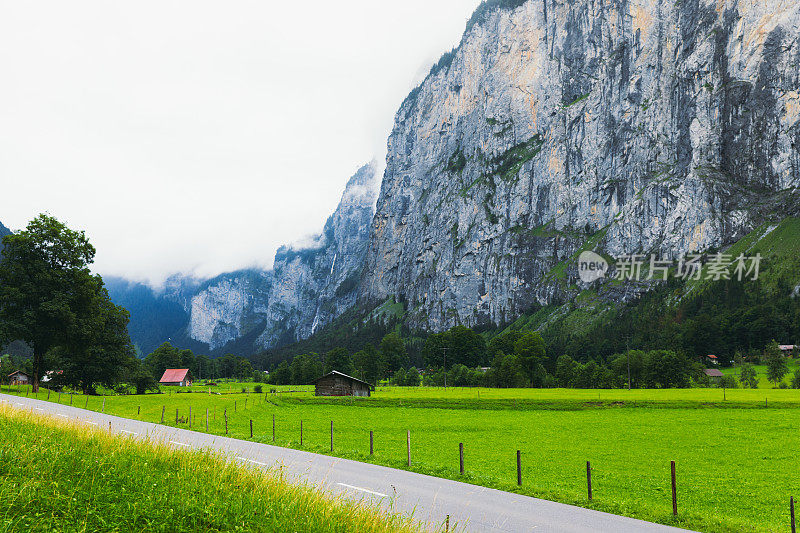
[360, 0, 800, 330]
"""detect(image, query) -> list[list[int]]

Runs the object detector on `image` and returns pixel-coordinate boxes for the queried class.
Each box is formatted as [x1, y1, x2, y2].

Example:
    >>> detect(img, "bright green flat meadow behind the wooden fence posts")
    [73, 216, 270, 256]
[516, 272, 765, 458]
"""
[3, 387, 800, 531]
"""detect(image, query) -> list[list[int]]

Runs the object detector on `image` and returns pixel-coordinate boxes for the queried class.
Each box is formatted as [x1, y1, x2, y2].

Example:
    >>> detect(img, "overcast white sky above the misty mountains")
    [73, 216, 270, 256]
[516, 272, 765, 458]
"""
[0, 0, 479, 283]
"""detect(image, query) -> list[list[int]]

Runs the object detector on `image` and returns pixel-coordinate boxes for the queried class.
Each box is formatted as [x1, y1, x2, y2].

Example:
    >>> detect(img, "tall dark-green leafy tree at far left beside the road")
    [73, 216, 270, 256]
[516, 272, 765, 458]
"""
[0, 215, 97, 391]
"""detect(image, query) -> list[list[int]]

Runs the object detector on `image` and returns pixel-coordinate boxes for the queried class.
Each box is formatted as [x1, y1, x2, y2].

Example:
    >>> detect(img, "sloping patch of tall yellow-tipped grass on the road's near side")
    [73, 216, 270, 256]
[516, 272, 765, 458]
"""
[0, 407, 413, 532]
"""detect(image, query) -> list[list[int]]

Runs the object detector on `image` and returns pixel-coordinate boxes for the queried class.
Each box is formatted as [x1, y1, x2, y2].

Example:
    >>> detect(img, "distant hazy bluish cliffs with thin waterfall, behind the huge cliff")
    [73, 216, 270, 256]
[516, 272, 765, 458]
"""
[159, 163, 377, 353]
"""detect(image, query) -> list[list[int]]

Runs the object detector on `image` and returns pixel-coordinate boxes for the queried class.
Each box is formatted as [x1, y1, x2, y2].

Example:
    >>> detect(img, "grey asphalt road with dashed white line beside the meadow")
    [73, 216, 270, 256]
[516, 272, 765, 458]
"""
[0, 394, 692, 533]
